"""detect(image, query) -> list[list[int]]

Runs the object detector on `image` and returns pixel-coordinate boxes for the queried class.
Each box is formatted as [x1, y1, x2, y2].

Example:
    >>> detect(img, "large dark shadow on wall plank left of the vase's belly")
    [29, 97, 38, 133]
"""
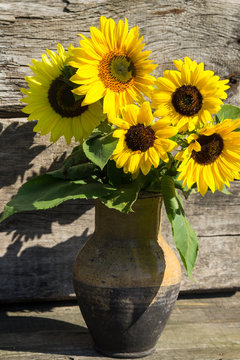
[0, 221, 93, 302]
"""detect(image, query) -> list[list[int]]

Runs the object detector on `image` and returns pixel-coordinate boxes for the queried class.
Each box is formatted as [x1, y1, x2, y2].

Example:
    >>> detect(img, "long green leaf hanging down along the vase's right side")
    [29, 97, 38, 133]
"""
[162, 175, 198, 279]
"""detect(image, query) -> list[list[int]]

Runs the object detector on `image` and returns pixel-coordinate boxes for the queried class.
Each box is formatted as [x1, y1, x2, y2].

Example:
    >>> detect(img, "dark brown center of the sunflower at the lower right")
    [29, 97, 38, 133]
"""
[192, 133, 224, 165]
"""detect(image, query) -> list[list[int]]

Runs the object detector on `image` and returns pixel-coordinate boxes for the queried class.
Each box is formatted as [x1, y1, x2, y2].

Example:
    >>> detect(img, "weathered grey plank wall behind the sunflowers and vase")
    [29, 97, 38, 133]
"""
[0, 0, 240, 302]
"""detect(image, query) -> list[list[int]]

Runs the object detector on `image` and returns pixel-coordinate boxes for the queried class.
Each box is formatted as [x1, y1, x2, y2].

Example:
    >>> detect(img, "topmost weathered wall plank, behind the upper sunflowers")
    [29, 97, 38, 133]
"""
[0, 0, 240, 117]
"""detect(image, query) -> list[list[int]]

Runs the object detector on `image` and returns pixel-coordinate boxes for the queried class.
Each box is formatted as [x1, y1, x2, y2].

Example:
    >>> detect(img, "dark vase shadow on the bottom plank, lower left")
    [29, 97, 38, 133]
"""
[0, 306, 95, 356]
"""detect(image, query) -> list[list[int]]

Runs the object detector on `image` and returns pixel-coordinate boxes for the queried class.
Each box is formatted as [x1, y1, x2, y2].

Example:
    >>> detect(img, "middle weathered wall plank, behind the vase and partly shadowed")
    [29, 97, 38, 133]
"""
[0, 119, 240, 302]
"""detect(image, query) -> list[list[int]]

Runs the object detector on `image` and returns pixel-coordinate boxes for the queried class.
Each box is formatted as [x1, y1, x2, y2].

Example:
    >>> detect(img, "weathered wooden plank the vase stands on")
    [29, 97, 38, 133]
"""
[0, 293, 240, 360]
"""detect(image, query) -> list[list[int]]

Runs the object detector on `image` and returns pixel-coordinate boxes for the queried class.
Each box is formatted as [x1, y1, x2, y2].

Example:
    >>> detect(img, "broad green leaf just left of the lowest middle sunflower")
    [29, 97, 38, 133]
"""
[83, 122, 118, 169]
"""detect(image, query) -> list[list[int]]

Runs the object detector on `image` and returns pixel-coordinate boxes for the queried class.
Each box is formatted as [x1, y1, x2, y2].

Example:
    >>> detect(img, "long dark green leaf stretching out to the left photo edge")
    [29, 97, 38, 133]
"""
[0, 174, 116, 222]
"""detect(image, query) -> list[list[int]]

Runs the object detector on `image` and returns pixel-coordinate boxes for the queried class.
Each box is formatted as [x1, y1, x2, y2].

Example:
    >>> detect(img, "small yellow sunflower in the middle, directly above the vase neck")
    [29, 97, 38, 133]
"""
[111, 101, 177, 178]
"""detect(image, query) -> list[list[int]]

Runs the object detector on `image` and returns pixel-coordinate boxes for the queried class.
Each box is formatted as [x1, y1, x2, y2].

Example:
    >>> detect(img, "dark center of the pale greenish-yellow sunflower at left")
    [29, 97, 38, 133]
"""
[48, 77, 88, 117]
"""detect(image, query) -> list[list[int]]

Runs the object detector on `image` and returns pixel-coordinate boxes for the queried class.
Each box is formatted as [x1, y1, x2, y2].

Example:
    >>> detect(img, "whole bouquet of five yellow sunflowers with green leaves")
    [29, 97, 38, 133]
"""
[1, 16, 240, 277]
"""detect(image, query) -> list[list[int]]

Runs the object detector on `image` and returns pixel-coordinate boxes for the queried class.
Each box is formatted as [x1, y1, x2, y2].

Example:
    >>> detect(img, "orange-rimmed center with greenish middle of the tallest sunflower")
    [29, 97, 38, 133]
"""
[98, 50, 136, 92]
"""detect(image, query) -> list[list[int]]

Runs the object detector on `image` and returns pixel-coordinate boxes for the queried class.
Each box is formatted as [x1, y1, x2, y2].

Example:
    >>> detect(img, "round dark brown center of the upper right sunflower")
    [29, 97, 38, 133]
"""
[172, 85, 203, 116]
